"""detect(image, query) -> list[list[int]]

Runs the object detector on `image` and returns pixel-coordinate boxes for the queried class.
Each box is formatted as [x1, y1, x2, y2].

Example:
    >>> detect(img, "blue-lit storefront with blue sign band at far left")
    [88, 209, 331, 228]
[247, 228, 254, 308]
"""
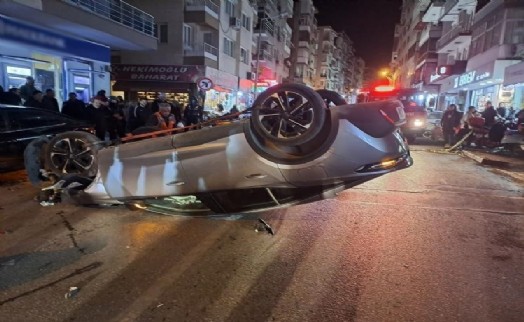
[0, 15, 110, 106]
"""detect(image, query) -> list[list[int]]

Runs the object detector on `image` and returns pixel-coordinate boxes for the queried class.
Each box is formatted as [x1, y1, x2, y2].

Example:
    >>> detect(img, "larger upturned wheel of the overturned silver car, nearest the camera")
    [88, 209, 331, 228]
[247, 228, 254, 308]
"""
[250, 84, 327, 146]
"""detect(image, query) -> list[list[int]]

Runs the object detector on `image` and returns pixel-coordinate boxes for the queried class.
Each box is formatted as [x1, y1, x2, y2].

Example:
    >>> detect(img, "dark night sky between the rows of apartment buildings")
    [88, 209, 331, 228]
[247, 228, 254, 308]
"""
[313, 0, 402, 69]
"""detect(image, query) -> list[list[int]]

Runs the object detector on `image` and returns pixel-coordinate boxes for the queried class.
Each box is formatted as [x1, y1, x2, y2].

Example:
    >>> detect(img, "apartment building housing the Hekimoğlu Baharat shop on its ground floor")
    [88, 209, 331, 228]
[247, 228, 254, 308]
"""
[116, 0, 256, 110]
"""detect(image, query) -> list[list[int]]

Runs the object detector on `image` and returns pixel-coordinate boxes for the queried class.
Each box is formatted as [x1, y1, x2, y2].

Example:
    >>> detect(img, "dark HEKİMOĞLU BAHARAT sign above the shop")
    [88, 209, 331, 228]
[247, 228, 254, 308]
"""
[111, 64, 205, 83]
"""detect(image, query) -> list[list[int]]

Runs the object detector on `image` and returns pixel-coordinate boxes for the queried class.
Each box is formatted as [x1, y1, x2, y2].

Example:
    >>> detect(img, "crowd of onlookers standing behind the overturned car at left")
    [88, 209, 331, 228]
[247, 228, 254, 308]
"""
[0, 76, 233, 140]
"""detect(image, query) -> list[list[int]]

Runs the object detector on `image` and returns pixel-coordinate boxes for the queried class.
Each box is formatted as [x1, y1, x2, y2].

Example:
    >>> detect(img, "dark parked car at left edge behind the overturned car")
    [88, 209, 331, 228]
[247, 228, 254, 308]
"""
[0, 104, 92, 172]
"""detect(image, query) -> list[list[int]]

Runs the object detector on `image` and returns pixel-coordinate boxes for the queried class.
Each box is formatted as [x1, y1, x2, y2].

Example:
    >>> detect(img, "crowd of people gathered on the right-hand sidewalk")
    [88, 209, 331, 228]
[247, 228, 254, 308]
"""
[440, 101, 524, 147]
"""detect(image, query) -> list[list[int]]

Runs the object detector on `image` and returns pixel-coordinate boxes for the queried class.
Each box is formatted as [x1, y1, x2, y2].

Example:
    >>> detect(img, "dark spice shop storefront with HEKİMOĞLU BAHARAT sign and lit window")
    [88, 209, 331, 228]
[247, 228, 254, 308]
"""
[111, 64, 205, 105]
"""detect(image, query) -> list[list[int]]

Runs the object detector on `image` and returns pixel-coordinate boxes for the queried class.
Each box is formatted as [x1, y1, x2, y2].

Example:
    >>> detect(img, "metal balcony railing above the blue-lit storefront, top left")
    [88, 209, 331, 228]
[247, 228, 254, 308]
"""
[62, 0, 155, 37]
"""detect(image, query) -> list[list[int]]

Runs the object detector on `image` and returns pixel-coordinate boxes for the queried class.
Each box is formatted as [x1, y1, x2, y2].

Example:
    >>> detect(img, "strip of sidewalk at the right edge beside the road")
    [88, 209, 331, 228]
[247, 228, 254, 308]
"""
[459, 150, 524, 183]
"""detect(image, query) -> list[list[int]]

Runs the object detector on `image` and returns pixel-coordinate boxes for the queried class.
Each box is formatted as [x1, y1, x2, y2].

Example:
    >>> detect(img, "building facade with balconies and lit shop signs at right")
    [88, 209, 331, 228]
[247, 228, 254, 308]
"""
[392, 0, 524, 111]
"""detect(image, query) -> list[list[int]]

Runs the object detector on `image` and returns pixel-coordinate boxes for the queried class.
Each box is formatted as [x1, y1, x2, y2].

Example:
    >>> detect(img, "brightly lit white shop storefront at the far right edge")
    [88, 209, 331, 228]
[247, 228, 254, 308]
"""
[501, 62, 524, 110]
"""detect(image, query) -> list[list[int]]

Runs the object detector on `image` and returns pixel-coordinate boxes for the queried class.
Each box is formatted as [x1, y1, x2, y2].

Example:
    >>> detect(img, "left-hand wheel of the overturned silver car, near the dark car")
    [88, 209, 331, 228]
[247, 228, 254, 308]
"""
[46, 132, 101, 177]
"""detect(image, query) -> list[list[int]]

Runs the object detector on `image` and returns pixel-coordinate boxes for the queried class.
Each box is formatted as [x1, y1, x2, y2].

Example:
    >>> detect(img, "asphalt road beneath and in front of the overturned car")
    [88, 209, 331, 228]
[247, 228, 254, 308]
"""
[0, 146, 524, 322]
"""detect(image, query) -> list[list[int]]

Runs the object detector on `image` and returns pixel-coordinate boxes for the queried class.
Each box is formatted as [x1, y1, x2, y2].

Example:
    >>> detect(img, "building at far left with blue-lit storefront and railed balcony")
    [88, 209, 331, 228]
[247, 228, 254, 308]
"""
[0, 0, 157, 106]
